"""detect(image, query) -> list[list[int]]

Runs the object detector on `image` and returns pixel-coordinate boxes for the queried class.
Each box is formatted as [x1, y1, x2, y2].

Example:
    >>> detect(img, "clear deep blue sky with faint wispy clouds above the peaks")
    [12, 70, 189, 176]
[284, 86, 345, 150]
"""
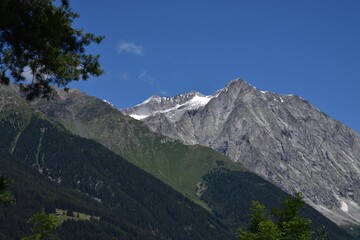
[71, 0, 360, 132]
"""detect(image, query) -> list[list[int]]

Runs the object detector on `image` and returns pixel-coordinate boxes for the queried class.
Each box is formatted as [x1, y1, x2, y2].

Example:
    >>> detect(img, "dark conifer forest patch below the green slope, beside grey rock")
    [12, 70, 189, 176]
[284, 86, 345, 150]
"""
[201, 169, 353, 240]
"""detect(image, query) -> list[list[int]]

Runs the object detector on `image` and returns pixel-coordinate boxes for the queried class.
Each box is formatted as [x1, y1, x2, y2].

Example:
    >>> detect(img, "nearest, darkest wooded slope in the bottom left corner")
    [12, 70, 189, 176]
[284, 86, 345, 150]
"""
[0, 152, 152, 240]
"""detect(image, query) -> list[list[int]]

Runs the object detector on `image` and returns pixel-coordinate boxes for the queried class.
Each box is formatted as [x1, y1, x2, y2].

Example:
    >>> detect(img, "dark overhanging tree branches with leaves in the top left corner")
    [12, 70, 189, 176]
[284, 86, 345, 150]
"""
[0, 0, 103, 99]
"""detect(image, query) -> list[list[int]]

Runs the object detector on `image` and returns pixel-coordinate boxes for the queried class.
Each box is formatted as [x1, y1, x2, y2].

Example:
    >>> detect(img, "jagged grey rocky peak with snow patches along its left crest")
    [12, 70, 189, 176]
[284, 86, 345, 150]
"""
[122, 80, 360, 224]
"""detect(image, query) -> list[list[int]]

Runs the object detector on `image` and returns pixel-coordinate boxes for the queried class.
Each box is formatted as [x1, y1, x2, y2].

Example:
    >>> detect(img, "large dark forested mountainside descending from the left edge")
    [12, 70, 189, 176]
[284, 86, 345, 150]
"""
[0, 87, 235, 239]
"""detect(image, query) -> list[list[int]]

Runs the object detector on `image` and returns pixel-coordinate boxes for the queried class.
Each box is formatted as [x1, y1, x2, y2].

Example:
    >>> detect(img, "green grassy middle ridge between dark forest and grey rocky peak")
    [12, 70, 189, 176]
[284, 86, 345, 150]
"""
[31, 86, 244, 207]
